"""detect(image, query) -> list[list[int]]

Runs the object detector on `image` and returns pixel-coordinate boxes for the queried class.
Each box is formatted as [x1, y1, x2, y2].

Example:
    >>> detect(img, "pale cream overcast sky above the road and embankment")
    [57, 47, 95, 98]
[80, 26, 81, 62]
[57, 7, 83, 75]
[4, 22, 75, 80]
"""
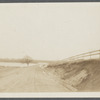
[0, 3, 100, 60]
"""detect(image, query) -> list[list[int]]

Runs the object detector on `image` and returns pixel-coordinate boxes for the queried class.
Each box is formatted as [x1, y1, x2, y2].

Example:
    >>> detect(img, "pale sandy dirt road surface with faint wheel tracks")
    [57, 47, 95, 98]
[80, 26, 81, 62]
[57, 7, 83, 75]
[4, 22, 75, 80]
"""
[0, 66, 69, 92]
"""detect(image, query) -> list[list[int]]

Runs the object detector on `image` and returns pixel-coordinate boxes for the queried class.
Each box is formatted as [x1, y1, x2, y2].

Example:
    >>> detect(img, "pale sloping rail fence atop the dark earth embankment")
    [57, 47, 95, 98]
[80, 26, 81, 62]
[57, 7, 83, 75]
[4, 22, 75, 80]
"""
[65, 50, 100, 61]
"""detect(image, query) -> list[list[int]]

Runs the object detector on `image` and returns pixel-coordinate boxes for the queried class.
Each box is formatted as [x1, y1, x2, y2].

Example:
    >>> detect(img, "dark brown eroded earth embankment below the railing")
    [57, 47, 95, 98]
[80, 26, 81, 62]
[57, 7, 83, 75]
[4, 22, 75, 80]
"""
[46, 59, 100, 92]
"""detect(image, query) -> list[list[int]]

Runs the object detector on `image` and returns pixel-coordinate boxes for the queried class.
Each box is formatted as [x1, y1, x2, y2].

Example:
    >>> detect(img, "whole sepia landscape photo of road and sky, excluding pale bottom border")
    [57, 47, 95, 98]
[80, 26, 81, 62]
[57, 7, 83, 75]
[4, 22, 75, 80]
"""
[0, 3, 100, 93]
